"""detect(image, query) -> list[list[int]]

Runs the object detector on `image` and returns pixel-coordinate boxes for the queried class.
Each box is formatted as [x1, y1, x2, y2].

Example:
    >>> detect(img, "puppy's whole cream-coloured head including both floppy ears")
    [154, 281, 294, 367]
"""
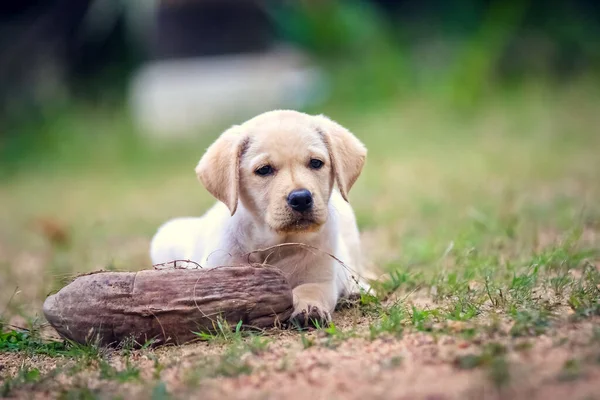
[196, 111, 367, 233]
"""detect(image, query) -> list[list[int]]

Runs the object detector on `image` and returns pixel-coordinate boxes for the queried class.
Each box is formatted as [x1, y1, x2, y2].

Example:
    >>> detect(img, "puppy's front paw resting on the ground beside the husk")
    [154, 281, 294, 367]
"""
[290, 282, 337, 327]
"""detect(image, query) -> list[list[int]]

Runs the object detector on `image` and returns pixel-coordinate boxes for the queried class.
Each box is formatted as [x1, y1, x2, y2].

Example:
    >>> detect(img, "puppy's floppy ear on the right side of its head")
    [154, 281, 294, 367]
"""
[315, 115, 367, 201]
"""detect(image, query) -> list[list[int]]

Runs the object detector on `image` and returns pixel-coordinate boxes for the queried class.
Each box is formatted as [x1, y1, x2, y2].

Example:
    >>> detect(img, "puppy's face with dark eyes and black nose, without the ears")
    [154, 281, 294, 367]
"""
[239, 114, 334, 233]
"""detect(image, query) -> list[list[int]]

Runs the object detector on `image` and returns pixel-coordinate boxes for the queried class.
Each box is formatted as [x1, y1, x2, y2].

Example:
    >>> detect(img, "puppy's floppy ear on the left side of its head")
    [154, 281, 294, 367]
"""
[196, 126, 248, 215]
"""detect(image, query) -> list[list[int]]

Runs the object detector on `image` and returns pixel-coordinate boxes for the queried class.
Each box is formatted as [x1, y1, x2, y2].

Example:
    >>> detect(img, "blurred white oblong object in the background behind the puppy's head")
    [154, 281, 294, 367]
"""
[130, 48, 327, 136]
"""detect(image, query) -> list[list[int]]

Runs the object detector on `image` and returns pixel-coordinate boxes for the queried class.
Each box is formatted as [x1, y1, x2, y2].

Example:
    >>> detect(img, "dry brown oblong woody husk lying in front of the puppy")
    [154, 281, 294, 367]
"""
[44, 266, 293, 345]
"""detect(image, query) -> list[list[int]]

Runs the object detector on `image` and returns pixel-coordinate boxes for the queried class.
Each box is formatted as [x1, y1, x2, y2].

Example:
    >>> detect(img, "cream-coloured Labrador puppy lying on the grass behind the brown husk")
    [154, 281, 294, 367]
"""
[150, 110, 368, 325]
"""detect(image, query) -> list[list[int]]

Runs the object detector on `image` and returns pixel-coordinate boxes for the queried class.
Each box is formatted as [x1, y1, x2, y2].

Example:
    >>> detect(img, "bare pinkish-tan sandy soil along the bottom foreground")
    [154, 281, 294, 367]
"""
[0, 310, 600, 400]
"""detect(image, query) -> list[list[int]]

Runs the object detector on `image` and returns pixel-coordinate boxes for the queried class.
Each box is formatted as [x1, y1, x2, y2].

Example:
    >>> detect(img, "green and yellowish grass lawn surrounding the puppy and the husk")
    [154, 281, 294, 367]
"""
[0, 80, 600, 399]
